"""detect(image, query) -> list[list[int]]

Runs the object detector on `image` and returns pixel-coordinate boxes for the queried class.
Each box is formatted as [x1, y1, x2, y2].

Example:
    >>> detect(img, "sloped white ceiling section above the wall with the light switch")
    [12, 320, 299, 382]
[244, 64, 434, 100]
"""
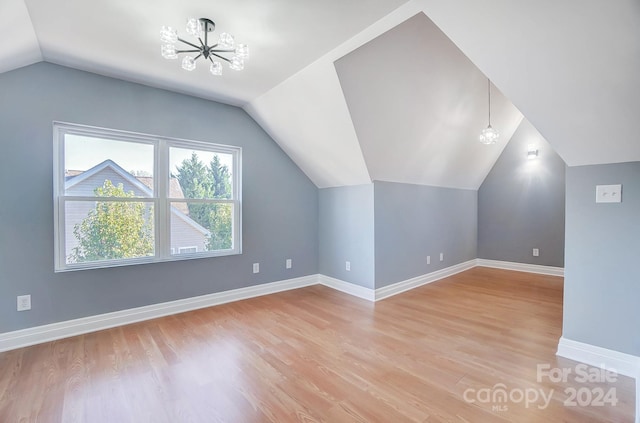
[424, 0, 640, 166]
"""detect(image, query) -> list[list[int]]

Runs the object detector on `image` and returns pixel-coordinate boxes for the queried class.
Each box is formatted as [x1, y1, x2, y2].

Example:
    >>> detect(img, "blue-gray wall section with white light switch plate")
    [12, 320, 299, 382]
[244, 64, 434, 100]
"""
[563, 162, 640, 356]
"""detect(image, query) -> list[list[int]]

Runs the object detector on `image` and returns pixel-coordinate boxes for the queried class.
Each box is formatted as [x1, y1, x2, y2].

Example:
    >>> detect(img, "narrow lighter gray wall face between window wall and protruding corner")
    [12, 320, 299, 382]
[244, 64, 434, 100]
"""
[318, 184, 375, 289]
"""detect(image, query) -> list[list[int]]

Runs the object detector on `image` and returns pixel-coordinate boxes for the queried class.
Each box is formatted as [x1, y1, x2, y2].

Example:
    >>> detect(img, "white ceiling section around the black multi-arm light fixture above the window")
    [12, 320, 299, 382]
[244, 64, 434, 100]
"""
[16, 0, 402, 105]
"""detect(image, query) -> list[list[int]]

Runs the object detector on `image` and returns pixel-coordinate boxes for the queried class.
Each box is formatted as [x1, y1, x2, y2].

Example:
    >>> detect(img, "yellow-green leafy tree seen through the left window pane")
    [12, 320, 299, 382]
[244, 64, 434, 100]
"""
[70, 179, 154, 263]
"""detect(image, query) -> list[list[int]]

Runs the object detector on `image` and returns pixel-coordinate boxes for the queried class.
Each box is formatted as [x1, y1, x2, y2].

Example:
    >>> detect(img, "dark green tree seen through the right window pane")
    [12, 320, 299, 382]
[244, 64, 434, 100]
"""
[176, 152, 233, 251]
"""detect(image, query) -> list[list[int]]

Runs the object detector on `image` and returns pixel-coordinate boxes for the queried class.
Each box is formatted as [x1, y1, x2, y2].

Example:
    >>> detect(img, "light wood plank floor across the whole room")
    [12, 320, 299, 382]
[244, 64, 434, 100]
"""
[0, 268, 635, 423]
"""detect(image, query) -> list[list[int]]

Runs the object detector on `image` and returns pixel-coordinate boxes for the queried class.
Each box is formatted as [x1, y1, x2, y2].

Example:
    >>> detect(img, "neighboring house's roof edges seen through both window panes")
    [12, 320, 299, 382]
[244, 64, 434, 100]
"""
[64, 160, 211, 235]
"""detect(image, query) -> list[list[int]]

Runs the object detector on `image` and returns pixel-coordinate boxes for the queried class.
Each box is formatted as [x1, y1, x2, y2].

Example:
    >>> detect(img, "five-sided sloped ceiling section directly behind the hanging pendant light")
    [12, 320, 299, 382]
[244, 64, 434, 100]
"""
[335, 13, 522, 189]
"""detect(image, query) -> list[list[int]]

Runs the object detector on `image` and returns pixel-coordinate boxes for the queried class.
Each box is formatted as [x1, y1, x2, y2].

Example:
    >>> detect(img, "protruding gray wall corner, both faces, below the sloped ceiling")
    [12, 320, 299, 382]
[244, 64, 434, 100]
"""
[318, 181, 477, 289]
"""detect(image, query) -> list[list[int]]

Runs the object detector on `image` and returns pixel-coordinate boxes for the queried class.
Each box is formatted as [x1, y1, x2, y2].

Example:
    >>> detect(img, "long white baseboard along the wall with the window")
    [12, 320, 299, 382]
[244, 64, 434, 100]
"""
[0, 275, 318, 352]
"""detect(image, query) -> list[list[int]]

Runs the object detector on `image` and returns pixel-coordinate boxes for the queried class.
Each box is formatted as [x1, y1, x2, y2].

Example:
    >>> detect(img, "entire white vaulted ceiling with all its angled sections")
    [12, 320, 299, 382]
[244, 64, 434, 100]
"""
[5, 0, 640, 189]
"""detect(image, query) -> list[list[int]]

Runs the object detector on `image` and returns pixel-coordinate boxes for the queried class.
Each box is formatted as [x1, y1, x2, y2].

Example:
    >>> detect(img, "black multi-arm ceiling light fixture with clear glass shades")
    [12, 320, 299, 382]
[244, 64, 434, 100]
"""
[160, 18, 249, 75]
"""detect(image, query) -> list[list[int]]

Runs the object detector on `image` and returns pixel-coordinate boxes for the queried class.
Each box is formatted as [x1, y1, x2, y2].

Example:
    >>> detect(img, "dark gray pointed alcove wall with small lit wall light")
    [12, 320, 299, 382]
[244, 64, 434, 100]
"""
[478, 119, 566, 267]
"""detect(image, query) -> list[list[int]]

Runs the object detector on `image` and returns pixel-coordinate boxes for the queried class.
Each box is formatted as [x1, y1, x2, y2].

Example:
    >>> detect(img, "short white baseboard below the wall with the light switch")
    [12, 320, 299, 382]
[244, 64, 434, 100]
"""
[556, 337, 640, 378]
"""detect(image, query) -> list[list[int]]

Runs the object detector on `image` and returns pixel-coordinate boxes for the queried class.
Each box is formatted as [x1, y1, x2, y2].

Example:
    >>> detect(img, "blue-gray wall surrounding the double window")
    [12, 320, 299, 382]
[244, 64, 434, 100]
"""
[0, 63, 318, 333]
